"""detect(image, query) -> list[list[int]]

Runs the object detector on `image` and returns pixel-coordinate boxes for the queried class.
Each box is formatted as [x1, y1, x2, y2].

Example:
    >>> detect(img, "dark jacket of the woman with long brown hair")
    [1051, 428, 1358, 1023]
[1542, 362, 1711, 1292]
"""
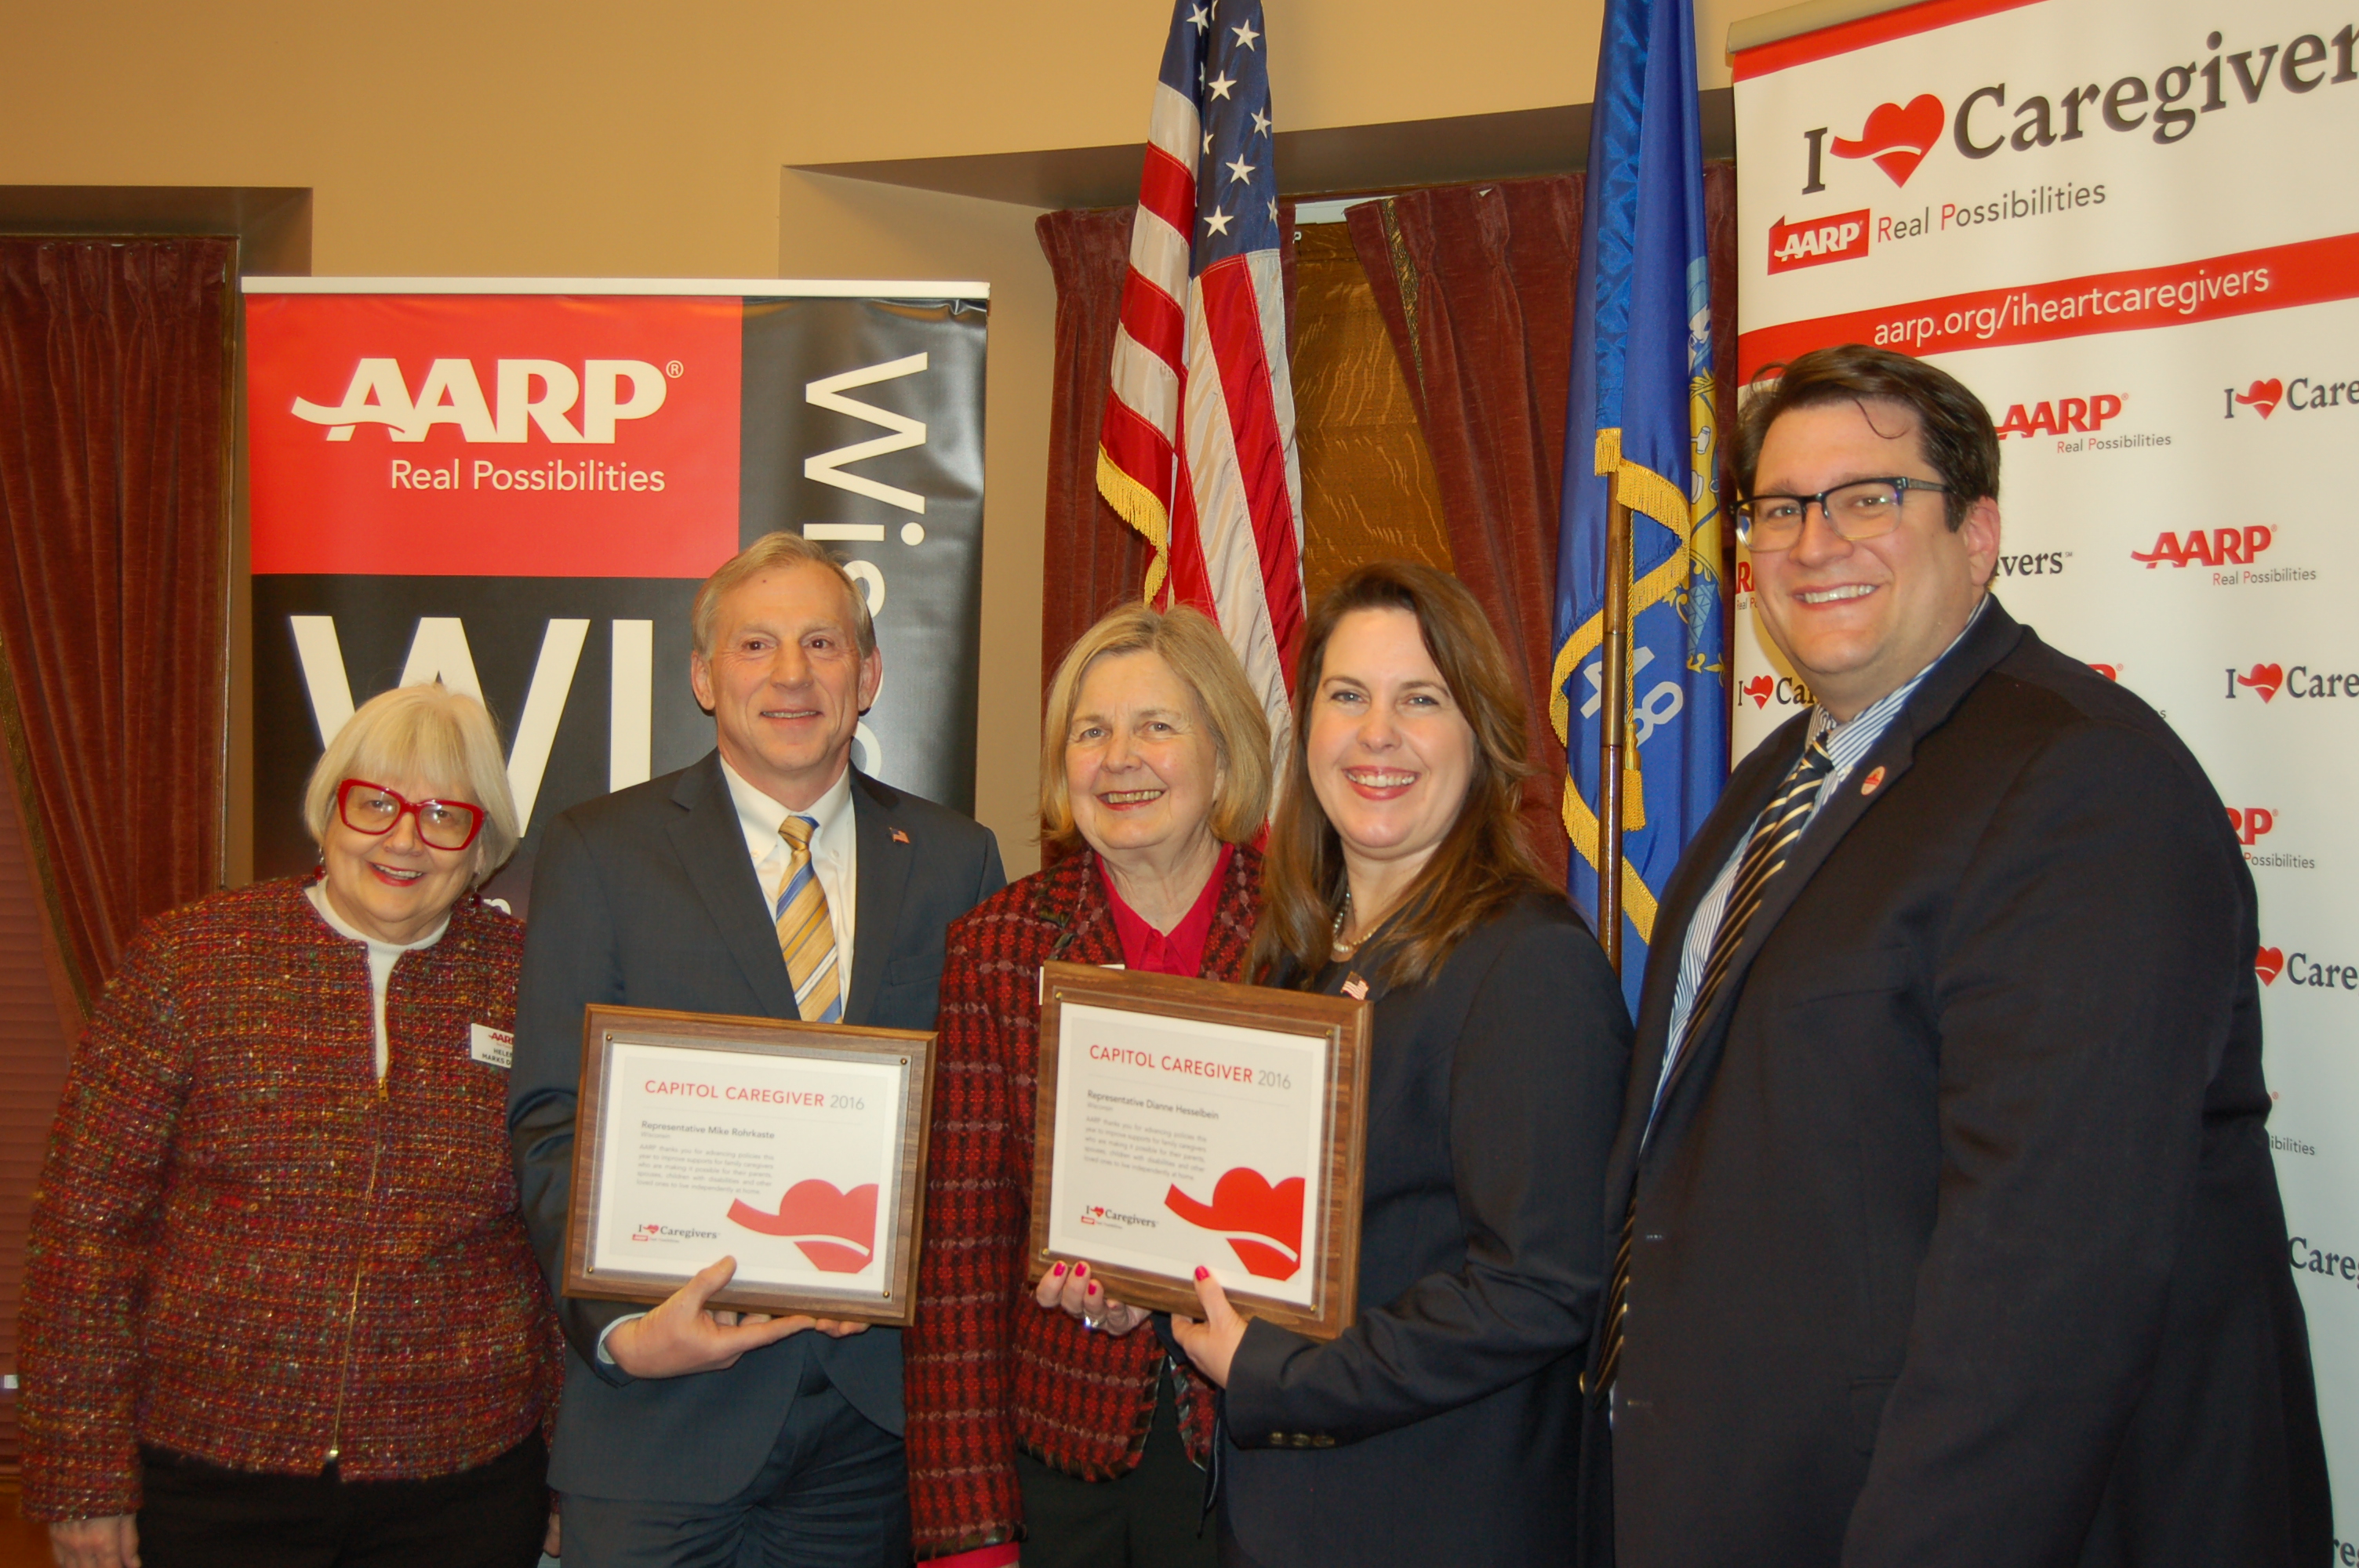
[1222, 891, 1630, 1568]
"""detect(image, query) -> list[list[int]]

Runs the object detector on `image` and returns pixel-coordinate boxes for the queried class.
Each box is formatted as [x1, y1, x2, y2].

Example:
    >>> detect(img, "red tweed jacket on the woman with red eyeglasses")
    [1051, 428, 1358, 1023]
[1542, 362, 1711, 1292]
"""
[19, 880, 562, 1519]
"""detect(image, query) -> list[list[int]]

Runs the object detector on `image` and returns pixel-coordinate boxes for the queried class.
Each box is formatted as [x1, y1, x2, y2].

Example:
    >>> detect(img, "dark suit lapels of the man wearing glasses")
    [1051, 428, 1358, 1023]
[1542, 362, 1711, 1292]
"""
[1663, 599, 2024, 1127]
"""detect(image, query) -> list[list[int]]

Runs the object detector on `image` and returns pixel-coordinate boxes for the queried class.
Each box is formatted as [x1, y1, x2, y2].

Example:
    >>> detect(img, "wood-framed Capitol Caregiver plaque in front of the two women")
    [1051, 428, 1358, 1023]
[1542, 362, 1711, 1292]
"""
[1030, 964, 1369, 1339]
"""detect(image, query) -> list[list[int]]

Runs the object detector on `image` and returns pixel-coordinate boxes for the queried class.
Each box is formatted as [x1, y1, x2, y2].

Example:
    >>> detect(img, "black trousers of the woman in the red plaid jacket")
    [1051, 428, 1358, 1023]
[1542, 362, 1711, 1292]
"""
[1016, 1374, 1219, 1568]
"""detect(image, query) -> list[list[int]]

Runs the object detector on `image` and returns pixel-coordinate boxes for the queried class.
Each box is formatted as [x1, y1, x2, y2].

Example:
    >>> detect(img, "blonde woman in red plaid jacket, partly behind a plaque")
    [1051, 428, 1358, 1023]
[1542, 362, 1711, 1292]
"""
[901, 606, 1271, 1568]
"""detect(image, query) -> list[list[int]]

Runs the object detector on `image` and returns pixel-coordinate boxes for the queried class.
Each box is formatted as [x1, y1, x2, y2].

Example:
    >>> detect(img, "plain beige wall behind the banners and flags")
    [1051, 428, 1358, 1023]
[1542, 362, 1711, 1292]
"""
[0, 0, 1774, 870]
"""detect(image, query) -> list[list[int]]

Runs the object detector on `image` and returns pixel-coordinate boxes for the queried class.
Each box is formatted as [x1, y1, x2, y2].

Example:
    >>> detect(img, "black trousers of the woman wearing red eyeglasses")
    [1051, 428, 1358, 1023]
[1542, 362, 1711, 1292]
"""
[139, 1434, 550, 1568]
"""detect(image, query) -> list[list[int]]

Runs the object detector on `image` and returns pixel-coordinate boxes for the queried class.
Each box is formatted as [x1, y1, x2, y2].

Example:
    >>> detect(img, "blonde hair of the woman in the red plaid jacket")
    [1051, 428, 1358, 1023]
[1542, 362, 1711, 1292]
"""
[1041, 604, 1269, 849]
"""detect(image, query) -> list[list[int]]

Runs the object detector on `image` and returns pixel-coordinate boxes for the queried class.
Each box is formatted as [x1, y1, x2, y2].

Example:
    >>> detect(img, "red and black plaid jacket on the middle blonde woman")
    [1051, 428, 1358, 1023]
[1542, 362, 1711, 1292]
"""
[901, 847, 1262, 1559]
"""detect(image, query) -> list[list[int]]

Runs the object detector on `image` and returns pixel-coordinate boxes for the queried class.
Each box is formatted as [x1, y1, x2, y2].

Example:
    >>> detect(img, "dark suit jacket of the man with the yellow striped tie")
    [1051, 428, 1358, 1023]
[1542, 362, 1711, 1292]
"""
[507, 752, 1007, 1502]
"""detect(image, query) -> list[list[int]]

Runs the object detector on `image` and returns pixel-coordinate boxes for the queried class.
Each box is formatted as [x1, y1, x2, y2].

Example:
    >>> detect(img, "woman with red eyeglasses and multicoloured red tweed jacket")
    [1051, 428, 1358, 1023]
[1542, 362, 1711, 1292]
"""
[19, 684, 562, 1568]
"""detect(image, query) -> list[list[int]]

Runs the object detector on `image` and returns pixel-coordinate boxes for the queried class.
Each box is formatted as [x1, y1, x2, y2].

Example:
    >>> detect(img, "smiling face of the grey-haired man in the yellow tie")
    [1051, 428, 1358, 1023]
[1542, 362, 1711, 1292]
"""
[689, 566, 885, 811]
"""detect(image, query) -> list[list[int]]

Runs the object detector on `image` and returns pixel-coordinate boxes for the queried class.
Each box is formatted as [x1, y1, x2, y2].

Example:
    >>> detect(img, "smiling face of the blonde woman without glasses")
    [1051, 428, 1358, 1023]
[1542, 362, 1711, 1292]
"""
[1064, 651, 1219, 873]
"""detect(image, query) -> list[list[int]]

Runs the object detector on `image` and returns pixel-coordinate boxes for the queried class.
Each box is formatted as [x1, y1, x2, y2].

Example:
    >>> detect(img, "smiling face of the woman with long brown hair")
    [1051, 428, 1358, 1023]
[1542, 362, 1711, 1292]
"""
[1304, 608, 1474, 886]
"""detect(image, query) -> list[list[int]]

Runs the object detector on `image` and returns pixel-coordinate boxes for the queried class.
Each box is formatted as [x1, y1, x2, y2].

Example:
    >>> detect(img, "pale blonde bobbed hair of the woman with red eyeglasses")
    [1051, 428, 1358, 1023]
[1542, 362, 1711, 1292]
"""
[302, 681, 524, 887]
